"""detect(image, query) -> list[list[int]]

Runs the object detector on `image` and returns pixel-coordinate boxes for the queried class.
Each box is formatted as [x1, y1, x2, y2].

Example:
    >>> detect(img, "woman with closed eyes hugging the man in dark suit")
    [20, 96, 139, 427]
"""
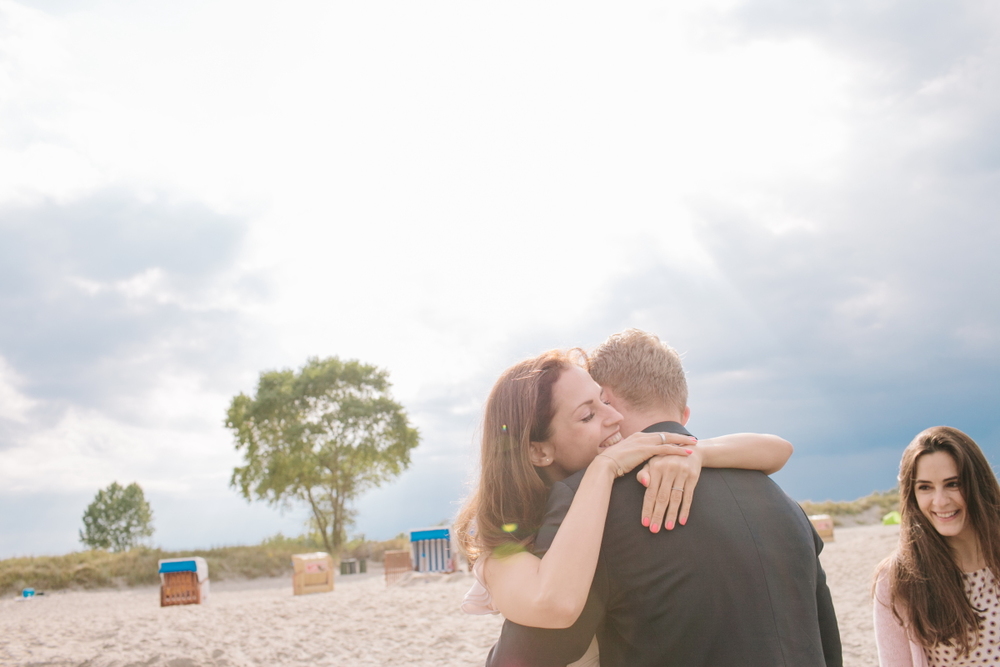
[456, 351, 791, 664]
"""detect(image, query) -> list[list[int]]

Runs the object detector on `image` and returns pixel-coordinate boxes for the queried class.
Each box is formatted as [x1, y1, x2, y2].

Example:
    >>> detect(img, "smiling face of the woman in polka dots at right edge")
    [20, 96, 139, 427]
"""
[913, 452, 972, 538]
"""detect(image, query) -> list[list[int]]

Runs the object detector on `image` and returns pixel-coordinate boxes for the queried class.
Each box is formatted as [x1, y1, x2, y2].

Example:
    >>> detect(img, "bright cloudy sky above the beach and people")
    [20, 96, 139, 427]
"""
[0, 0, 1000, 558]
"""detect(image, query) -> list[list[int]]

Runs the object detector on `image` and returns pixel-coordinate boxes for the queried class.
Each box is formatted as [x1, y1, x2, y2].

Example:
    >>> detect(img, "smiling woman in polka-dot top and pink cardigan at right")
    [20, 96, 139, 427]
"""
[874, 426, 1000, 667]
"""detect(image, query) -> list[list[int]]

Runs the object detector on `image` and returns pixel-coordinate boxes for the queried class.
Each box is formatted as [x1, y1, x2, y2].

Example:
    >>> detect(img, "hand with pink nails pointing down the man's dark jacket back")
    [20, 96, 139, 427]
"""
[636, 447, 703, 533]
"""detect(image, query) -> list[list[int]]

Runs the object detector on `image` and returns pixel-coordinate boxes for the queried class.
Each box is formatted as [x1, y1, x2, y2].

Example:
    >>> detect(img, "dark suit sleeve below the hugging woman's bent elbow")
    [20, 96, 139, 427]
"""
[486, 565, 607, 667]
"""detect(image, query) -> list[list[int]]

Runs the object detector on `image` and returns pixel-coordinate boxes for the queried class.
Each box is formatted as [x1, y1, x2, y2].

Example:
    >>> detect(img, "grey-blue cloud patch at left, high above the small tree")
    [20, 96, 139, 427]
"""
[0, 192, 261, 418]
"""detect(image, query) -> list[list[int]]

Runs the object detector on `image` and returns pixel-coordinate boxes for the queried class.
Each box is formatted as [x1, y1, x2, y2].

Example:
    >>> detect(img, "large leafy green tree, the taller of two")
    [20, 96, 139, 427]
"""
[226, 357, 419, 553]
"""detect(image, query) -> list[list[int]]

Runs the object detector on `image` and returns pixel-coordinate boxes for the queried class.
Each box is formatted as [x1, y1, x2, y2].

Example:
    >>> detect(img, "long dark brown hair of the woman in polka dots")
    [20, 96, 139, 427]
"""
[879, 426, 1000, 654]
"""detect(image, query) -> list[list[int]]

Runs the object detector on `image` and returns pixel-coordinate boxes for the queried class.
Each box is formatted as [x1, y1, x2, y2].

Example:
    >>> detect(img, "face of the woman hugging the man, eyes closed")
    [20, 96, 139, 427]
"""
[546, 366, 622, 479]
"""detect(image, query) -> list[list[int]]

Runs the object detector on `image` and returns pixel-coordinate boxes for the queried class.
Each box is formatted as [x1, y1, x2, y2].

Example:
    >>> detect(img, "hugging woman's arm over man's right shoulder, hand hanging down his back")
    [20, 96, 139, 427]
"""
[636, 433, 792, 533]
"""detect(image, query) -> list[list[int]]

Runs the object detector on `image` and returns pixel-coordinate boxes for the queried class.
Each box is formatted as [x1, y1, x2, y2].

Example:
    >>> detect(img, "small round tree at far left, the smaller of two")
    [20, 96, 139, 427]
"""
[80, 482, 153, 551]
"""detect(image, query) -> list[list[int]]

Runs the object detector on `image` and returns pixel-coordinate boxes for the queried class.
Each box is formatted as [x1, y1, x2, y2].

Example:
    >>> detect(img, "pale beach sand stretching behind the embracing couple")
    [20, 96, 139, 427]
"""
[0, 526, 898, 667]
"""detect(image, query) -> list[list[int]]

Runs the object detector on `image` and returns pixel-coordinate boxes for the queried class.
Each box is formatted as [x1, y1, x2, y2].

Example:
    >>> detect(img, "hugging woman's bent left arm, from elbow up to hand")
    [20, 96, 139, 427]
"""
[484, 433, 694, 628]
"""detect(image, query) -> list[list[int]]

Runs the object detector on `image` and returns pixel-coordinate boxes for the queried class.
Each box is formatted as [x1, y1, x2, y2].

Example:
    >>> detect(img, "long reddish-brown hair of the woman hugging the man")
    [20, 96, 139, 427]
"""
[455, 350, 578, 562]
